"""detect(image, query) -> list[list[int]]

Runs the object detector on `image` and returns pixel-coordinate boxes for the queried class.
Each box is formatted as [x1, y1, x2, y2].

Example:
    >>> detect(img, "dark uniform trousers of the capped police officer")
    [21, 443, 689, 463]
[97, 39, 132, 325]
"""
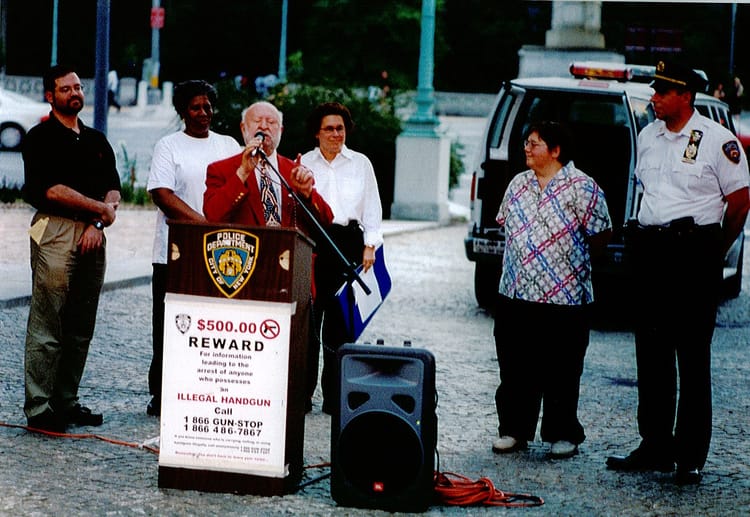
[632, 220, 722, 469]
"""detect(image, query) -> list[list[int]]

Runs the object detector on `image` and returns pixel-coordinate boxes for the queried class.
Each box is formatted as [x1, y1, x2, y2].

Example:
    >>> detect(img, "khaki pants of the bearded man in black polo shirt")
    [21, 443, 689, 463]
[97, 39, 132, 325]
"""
[24, 213, 106, 417]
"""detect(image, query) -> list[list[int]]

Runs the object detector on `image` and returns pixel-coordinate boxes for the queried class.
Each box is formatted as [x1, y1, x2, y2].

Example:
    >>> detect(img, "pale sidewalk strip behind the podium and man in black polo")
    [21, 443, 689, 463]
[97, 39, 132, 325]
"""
[0, 204, 452, 308]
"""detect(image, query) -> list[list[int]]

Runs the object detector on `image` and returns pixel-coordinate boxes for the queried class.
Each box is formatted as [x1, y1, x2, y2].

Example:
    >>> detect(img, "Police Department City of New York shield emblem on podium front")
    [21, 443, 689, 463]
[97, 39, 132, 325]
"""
[203, 229, 258, 298]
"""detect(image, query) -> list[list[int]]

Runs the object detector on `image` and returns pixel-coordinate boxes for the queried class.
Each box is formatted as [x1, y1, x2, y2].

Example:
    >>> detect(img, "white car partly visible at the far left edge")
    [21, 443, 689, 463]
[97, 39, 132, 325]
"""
[0, 88, 50, 151]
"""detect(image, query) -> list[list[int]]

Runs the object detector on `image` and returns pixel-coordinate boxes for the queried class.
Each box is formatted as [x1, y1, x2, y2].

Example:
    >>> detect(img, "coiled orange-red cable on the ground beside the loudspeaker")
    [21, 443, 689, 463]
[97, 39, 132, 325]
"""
[435, 472, 544, 507]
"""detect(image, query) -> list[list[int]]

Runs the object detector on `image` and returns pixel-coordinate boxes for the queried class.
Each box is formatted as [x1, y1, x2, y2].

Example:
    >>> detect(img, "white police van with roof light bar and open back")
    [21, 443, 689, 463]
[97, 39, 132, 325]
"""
[464, 63, 744, 308]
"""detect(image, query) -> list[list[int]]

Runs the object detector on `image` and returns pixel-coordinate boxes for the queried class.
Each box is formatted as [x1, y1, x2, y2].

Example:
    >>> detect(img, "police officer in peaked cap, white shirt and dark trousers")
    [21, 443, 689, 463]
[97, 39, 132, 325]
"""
[607, 62, 750, 484]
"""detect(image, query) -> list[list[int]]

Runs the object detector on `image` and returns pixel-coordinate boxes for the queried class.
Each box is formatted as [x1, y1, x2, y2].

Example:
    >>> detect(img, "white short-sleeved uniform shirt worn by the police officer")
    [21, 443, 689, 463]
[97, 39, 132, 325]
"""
[635, 111, 748, 225]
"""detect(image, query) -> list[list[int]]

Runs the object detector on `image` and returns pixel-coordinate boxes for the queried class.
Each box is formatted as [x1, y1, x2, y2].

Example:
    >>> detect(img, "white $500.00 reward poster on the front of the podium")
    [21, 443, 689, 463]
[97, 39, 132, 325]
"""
[159, 293, 295, 478]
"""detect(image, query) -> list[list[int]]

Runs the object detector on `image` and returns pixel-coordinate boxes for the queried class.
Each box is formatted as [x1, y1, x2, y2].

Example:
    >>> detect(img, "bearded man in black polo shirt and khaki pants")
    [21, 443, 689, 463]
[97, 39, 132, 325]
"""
[23, 65, 120, 432]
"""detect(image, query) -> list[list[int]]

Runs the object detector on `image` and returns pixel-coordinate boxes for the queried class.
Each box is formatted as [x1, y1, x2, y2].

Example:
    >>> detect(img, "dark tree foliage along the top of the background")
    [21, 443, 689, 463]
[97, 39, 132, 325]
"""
[0, 0, 750, 92]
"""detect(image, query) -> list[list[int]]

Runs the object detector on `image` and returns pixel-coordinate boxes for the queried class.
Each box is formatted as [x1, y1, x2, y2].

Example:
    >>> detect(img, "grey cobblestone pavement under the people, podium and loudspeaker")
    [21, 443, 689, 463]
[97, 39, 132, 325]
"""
[0, 225, 750, 516]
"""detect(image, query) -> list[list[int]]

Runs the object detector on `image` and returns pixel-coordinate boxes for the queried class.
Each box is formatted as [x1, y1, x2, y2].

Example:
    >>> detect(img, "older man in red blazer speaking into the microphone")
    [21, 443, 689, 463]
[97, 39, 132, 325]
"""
[203, 102, 333, 230]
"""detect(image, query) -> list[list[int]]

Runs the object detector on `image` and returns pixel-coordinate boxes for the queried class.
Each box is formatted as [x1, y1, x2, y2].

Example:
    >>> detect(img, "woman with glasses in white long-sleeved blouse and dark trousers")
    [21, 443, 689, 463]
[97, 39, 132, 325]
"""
[302, 102, 383, 414]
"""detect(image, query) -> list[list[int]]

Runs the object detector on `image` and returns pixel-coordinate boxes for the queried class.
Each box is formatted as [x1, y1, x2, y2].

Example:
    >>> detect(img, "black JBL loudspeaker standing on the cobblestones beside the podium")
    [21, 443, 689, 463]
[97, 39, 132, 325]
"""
[331, 344, 437, 511]
